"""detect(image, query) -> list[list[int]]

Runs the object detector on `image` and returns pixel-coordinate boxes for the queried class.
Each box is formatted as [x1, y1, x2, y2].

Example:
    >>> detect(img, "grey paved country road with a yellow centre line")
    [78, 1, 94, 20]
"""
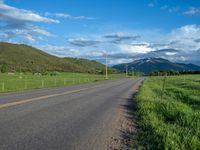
[0, 78, 142, 150]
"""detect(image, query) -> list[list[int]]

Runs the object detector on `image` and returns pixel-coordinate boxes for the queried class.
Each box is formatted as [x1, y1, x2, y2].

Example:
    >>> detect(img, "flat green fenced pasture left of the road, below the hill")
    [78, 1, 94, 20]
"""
[0, 73, 125, 92]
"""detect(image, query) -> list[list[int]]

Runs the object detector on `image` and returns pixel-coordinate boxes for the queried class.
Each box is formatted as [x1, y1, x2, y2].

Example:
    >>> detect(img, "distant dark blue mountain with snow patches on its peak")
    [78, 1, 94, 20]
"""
[113, 58, 200, 74]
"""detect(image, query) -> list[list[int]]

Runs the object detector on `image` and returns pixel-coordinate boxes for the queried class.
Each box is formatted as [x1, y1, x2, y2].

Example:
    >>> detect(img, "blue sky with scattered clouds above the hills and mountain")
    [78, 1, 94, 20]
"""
[0, 0, 200, 65]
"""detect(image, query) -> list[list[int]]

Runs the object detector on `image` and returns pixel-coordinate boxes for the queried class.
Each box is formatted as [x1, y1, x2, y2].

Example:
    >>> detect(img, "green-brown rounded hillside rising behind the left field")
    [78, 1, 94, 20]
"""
[0, 42, 105, 73]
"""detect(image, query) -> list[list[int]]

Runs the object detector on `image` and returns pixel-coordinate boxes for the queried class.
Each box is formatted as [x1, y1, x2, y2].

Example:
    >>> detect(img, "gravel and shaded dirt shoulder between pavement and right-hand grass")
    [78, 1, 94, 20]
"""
[107, 81, 141, 150]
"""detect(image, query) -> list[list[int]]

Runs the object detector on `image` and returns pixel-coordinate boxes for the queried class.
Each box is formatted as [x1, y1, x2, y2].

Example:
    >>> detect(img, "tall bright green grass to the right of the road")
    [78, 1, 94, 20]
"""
[137, 75, 200, 150]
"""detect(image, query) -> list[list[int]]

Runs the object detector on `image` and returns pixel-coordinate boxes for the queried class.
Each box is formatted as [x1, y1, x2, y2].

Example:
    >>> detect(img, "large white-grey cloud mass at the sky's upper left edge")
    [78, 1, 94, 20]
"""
[0, 1, 59, 42]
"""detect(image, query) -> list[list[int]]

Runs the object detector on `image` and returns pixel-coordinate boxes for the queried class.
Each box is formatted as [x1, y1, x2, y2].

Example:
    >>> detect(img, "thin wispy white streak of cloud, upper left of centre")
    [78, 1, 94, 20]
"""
[45, 12, 95, 20]
